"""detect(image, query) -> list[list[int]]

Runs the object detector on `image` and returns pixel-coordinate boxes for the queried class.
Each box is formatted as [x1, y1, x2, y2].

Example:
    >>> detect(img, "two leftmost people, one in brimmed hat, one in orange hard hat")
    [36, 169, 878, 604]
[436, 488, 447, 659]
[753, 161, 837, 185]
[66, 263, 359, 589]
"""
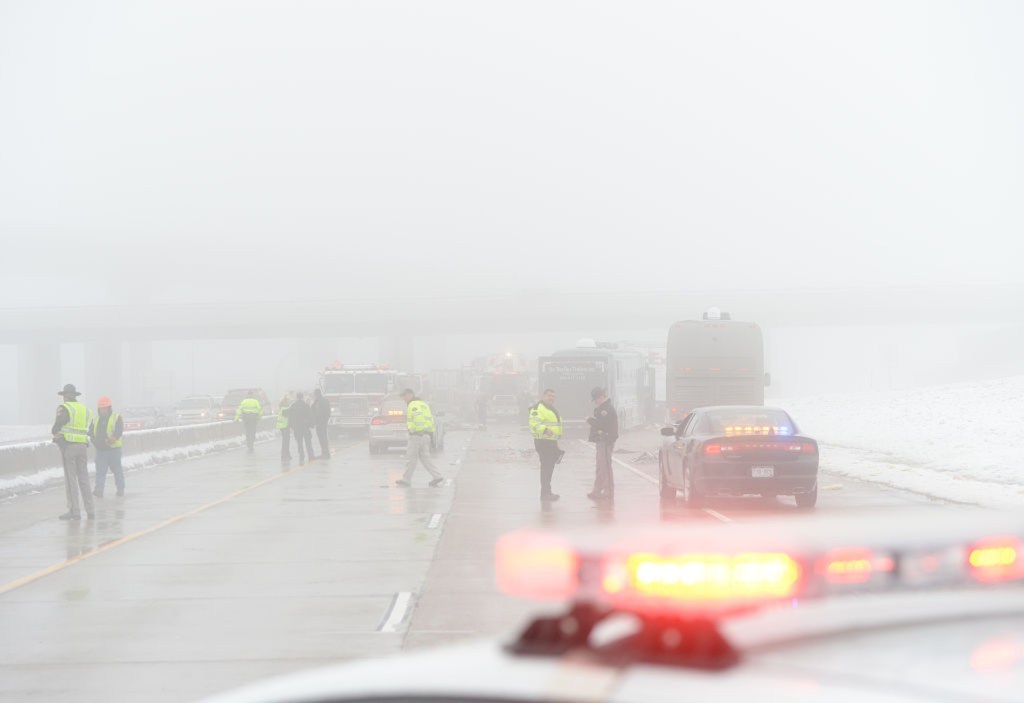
[50, 384, 125, 520]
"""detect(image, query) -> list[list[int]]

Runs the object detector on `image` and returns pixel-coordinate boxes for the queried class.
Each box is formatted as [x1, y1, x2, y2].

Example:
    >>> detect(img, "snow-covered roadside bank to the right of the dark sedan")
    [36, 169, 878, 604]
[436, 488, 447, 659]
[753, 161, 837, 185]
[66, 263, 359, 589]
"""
[769, 377, 1024, 508]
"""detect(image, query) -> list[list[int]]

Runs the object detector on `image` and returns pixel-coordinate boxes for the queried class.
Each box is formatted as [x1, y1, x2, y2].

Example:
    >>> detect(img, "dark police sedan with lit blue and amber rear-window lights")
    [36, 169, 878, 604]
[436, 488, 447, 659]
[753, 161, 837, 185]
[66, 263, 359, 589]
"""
[658, 405, 818, 508]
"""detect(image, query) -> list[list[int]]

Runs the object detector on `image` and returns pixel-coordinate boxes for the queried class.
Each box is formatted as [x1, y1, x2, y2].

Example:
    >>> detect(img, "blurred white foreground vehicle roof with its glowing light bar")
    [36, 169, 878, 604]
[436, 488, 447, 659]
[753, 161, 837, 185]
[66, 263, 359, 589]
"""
[203, 513, 1024, 703]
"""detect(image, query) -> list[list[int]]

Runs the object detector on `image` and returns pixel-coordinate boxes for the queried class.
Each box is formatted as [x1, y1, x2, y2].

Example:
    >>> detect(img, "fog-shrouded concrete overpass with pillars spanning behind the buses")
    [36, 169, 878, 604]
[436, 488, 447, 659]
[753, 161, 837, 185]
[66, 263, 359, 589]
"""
[0, 285, 1024, 419]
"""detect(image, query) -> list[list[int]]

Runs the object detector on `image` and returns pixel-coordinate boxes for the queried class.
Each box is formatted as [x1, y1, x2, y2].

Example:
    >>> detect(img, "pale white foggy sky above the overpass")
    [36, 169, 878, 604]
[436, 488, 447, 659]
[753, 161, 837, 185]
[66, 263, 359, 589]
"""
[0, 0, 1024, 305]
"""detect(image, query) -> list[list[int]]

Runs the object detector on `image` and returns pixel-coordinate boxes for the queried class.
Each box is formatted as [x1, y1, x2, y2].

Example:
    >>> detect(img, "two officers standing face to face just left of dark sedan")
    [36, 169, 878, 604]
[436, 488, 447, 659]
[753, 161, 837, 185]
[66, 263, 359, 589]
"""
[529, 388, 618, 504]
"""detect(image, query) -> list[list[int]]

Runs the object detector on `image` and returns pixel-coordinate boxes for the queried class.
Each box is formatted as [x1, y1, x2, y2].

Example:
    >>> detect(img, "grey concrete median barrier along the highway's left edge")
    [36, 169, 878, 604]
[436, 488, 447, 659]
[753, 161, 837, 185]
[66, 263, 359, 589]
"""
[0, 415, 275, 477]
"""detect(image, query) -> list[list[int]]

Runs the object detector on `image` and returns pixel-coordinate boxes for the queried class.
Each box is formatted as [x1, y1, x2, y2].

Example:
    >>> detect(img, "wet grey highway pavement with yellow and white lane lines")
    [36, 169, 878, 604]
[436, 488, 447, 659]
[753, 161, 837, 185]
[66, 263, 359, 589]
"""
[0, 426, 946, 703]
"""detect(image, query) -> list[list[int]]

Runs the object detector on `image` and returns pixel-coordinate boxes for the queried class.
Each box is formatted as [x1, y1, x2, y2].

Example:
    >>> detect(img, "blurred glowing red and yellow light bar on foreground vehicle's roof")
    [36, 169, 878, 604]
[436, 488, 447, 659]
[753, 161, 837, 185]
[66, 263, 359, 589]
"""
[496, 514, 1024, 615]
